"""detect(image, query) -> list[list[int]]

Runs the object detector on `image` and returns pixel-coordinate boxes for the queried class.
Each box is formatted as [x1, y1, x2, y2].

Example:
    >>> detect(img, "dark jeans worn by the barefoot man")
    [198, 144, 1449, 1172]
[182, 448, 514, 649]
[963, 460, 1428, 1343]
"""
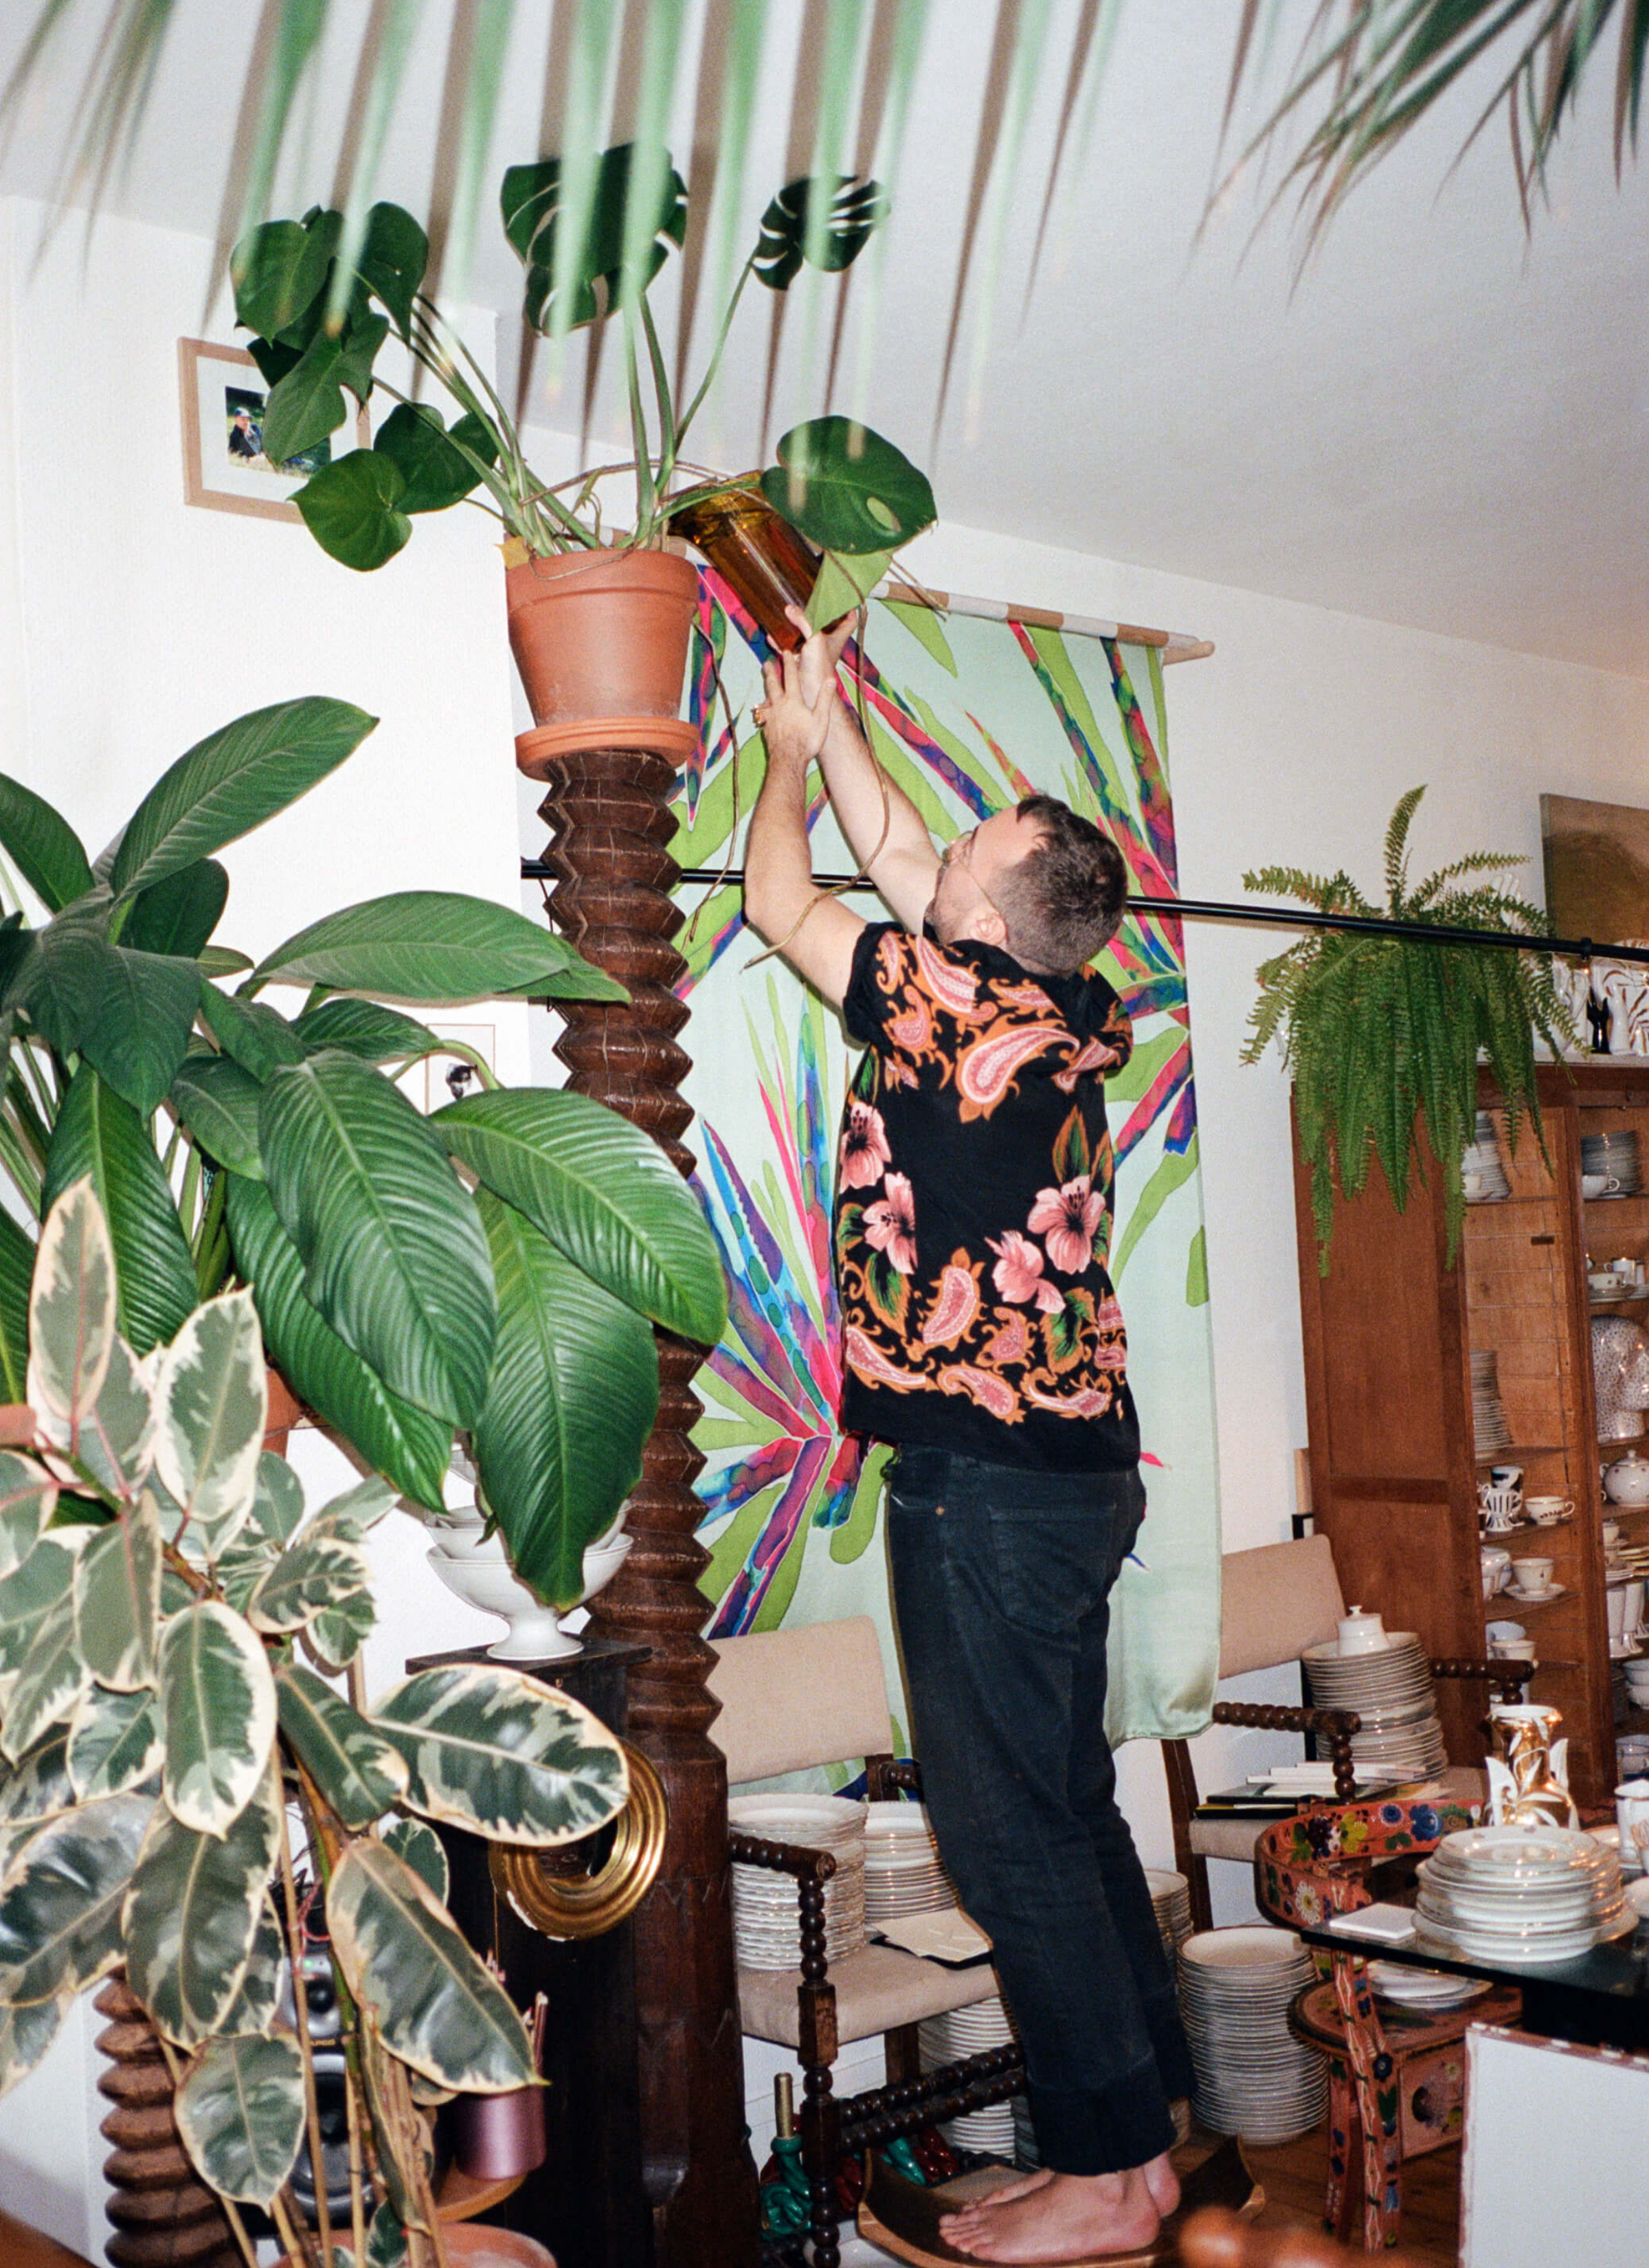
[887, 1449, 1191, 2172]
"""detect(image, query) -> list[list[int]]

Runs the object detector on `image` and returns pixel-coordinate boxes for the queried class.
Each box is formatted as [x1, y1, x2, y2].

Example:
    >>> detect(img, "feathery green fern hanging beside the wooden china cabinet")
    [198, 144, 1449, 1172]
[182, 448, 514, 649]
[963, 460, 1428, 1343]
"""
[1243, 787, 1574, 1275]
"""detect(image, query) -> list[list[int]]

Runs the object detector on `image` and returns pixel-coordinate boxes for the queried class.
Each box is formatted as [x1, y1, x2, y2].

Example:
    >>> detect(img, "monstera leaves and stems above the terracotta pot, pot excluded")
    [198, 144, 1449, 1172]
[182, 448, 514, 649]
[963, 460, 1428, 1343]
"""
[232, 143, 934, 612]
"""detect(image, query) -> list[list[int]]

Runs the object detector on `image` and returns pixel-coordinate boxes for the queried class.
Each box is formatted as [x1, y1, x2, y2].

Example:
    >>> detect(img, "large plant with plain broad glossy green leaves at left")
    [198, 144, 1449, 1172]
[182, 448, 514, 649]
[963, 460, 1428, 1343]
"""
[0, 698, 726, 1605]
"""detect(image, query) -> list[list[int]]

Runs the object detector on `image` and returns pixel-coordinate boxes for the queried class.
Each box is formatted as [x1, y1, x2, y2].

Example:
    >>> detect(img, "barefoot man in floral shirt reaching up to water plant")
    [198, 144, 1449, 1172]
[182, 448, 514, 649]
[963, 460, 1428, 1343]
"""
[744, 614, 1191, 2261]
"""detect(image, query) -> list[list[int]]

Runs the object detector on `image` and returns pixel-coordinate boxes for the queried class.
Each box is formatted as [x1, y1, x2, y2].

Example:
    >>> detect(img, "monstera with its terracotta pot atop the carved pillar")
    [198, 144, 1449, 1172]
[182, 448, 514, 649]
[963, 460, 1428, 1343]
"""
[232, 143, 934, 726]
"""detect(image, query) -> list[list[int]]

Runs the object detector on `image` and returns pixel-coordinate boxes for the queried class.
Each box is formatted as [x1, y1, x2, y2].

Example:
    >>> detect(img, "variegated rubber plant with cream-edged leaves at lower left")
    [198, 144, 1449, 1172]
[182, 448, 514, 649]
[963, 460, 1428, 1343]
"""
[0, 1175, 626, 2268]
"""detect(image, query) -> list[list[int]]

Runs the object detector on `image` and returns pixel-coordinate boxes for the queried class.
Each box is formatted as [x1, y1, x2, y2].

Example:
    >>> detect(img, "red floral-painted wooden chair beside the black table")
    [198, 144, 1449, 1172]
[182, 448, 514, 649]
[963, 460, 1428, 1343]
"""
[1255, 1803, 1518, 2252]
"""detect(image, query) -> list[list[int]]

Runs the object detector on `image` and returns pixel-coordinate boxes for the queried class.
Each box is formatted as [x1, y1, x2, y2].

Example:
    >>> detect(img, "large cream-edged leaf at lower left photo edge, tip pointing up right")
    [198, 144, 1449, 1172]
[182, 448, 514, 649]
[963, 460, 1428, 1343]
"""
[0, 1797, 154, 2003]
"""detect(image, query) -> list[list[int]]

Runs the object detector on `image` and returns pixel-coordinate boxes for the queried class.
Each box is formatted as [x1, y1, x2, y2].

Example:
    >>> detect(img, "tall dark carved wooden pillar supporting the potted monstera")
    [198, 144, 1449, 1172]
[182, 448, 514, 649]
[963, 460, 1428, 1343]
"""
[517, 721, 760, 2268]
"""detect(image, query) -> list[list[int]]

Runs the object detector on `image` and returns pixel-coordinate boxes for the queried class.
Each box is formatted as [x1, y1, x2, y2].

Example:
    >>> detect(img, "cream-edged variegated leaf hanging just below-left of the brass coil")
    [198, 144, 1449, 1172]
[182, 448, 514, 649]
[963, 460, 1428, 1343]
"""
[326, 1842, 535, 2093]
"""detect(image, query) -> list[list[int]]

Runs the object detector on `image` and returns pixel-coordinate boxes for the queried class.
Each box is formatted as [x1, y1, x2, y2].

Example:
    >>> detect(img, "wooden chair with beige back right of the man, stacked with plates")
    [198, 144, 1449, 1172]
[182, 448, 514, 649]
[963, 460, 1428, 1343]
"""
[1161, 1535, 1534, 1930]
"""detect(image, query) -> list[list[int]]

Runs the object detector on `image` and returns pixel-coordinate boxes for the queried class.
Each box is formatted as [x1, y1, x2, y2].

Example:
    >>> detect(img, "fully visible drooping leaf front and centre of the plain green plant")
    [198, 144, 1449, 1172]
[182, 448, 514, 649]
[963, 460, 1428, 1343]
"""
[258, 1055, 495, 1424]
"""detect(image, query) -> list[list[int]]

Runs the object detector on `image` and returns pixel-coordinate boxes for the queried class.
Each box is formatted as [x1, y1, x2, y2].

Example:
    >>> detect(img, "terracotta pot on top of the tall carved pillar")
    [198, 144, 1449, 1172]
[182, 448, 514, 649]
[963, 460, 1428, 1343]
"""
[504, 551, 699, 746]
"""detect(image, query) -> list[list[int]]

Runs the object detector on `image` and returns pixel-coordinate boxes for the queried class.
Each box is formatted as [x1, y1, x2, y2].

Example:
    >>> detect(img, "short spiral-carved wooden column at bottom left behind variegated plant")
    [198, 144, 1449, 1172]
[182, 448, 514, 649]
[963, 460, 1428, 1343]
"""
[93, 1975, 240, 2268]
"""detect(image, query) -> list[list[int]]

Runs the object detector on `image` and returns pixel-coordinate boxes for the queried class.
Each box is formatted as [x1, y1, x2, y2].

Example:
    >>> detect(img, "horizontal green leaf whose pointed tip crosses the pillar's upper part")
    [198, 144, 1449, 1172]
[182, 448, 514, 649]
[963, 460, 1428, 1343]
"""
[256, 889, 628, 1000]
